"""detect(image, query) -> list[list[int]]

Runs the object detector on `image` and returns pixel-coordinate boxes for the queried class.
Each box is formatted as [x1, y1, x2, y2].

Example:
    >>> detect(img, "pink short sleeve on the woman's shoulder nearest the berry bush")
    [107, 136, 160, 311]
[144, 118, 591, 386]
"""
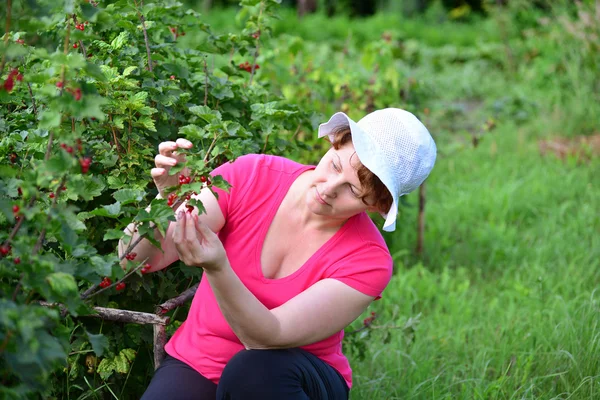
[210, 154, 262, 220]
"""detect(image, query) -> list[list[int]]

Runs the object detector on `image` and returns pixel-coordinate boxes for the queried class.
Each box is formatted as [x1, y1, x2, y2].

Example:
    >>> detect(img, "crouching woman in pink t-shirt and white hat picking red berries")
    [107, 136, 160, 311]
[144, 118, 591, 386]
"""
[125, 108, 436, 400]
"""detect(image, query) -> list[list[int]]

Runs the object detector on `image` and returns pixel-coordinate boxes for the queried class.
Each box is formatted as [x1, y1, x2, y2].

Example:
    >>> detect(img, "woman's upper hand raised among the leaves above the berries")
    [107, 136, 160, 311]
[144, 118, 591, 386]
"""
[150, 138, 193, 199]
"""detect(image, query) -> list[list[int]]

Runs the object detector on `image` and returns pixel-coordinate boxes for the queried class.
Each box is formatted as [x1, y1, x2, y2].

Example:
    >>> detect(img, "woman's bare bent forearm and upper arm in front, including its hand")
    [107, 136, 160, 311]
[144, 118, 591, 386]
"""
[173, 213, 374, 349]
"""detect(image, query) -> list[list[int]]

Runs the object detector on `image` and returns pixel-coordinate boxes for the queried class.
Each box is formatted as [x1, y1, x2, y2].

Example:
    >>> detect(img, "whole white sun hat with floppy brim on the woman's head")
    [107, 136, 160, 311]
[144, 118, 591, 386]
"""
[319, 108, 437, 232]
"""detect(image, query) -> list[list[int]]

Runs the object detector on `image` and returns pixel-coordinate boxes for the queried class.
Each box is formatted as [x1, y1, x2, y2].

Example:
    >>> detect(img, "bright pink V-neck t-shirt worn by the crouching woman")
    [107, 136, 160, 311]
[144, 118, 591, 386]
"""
[165, 154, 392, 387]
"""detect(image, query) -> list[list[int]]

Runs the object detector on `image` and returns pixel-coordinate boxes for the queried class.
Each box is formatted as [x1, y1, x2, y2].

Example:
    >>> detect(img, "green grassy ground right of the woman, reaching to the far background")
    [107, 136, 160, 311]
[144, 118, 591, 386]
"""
[191, 4, 600, 400]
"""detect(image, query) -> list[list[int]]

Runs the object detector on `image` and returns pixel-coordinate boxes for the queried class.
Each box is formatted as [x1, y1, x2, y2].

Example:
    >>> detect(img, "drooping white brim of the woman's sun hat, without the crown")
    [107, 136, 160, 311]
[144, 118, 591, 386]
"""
[318, 112, 398, 232]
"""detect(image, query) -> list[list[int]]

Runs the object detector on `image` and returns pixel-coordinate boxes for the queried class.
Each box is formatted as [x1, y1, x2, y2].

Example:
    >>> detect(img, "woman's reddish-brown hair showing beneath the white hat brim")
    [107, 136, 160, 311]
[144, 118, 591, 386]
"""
[331, 125, 393, 213]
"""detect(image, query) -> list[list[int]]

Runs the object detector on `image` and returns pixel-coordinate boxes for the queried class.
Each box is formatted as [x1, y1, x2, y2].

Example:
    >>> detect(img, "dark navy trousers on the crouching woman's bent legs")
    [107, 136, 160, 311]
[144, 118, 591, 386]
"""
[142, 348, 348, 400]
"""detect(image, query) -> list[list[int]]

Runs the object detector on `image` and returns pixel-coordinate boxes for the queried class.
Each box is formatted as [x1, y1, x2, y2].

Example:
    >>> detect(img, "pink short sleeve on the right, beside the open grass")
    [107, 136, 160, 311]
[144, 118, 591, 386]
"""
[328, 244, 393, 300]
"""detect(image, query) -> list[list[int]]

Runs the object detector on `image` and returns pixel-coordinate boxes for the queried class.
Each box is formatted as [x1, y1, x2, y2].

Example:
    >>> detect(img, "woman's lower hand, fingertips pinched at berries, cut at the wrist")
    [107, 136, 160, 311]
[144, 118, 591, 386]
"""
[173, 210, 227, 272]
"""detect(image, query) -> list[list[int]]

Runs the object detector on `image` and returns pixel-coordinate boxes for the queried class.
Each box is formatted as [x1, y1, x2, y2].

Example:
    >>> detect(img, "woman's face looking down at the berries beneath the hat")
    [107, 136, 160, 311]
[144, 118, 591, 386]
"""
[306, 142, 375, 219]
